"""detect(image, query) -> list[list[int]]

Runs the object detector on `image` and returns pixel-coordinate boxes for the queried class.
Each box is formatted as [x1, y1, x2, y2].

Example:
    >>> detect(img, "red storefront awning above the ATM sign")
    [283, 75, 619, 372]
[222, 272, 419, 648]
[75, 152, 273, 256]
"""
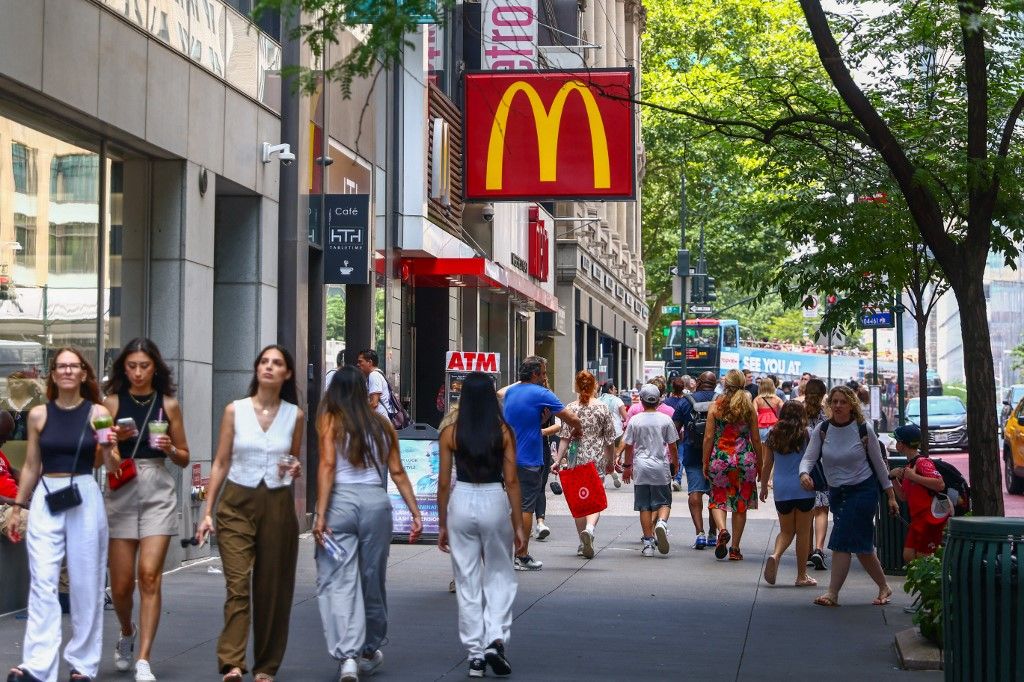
[402, 258, 558, 312]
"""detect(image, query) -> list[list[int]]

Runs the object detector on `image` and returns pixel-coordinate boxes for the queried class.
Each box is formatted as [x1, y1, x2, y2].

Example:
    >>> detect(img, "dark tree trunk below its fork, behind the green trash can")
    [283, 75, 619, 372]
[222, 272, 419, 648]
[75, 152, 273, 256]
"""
[950, 268, 1004, 516]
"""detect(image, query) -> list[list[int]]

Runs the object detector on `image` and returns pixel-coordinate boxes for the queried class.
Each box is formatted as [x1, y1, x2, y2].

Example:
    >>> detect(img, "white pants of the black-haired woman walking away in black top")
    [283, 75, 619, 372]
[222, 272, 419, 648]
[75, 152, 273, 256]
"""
[447, 481, 517, 659]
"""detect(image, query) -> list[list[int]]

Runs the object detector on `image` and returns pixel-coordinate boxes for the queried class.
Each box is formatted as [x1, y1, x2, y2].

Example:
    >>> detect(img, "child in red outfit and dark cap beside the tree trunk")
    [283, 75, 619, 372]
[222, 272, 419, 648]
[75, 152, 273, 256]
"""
[889, 424, 948, 561]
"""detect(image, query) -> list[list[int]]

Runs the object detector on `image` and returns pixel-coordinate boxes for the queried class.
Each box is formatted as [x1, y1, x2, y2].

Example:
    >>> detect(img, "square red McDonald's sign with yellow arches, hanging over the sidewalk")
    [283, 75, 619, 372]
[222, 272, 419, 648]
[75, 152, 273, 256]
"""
[463, 69, 636, 201]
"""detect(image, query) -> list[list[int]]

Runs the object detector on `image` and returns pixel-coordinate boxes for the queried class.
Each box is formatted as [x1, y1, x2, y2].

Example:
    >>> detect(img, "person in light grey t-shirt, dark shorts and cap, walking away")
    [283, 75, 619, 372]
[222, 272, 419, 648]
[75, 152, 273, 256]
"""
[623, 384, 679, 556]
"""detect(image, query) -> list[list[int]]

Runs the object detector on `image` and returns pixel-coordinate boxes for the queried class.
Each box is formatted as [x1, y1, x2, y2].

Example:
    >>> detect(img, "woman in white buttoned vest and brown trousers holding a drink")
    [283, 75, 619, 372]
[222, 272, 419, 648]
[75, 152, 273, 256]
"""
[196, 345, 305, 682]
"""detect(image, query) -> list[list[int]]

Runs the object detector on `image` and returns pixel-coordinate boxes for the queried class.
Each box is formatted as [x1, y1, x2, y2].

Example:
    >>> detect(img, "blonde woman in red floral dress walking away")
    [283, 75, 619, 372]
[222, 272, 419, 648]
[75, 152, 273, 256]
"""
[703, 370, 761, 561]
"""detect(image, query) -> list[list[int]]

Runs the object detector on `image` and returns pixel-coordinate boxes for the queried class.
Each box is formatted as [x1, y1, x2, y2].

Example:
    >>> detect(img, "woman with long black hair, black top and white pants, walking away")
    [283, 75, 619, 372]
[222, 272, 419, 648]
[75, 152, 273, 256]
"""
[437, 372, 524, 677]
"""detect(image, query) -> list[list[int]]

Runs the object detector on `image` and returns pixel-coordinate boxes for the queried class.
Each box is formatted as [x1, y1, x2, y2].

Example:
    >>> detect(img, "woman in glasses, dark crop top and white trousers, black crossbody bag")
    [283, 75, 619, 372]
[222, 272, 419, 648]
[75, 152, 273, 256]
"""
[5, 348, 121, 682]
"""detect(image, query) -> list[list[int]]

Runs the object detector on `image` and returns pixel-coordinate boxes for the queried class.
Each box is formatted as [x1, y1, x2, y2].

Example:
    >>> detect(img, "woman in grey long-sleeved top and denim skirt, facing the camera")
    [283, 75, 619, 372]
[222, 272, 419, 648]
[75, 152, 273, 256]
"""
[800, 386, 899, 606]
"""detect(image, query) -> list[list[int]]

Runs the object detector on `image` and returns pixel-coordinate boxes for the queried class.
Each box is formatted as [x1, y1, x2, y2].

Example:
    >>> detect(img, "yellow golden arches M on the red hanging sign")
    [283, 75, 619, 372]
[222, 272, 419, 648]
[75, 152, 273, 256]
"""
[486, 81, 611, 189]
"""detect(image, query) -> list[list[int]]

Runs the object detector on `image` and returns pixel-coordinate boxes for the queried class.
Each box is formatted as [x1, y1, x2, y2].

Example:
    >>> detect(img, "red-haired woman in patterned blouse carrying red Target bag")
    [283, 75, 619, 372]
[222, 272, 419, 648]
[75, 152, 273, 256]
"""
[552, 370, 615, 559]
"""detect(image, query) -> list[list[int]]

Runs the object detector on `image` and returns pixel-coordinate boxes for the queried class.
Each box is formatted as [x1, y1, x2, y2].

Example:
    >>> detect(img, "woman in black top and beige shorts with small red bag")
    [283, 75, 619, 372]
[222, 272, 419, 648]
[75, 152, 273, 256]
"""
[103, 338, 188, 682]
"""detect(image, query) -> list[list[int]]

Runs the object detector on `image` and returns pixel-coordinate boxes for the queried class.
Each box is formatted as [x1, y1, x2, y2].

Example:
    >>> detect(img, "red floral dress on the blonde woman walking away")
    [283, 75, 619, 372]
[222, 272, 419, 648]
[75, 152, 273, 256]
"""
[708, 419, 758, 512]
